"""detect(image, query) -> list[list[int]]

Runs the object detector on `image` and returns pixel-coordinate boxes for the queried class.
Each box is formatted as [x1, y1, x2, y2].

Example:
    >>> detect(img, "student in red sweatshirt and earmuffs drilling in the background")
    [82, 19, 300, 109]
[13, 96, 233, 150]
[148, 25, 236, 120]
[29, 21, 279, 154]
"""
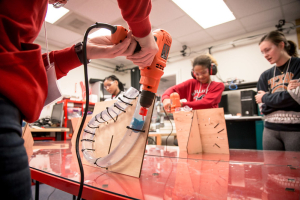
[162, 55, 225, 112]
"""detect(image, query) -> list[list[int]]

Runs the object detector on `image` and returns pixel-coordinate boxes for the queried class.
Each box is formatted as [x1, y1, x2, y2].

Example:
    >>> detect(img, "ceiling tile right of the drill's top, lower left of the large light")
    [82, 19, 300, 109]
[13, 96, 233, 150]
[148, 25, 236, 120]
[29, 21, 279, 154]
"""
[158, 16, 203, 38]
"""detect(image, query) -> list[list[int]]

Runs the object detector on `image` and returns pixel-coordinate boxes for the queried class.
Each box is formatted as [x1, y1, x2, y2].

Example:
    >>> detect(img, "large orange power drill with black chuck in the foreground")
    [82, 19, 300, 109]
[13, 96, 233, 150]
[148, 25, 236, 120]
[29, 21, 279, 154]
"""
[102, 24, 172, 116]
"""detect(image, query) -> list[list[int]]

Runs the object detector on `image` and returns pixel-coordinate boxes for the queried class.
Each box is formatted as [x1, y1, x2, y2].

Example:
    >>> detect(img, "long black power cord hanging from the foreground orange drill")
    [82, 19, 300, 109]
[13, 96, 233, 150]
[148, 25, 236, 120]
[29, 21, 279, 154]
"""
[75, 23, 114, 200]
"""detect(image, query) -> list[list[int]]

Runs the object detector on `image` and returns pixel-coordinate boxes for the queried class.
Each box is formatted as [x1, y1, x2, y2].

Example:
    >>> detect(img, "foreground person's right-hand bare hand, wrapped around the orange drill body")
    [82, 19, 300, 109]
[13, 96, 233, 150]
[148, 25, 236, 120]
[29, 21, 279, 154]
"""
[127, 32, 158, 69]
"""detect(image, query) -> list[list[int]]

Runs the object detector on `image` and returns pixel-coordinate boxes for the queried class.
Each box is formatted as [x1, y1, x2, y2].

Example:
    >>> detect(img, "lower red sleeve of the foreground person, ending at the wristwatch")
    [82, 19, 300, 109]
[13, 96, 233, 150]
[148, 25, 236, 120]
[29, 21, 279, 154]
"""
[42, 45, 82, 79]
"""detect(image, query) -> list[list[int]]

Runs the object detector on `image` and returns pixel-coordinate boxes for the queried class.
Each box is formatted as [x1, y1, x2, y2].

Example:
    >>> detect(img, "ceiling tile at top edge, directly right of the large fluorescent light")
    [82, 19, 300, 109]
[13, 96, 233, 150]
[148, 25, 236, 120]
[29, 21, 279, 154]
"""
[225, 0, 280, 18]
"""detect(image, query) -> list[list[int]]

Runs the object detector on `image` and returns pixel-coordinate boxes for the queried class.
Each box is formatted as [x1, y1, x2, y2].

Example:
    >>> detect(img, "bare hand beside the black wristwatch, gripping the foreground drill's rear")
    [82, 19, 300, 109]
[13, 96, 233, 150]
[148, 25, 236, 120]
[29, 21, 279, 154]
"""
[86, 31, 137, 60]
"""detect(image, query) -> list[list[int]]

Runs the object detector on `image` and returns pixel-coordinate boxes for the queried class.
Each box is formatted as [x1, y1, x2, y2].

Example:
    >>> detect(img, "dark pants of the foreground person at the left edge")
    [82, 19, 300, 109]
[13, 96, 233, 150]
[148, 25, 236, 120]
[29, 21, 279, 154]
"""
[0, 96, 31, 200]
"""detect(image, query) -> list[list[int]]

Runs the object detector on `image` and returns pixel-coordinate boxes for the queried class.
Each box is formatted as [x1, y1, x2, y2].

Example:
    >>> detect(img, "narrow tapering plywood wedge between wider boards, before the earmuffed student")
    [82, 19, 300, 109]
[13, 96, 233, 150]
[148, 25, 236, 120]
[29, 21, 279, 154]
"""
[187, 112, 202, 154]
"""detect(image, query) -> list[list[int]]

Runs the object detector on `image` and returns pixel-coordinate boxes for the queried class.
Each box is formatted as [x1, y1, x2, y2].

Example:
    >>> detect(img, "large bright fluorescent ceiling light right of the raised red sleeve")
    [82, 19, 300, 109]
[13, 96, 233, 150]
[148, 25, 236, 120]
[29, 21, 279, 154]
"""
[173, 0, 235, 29]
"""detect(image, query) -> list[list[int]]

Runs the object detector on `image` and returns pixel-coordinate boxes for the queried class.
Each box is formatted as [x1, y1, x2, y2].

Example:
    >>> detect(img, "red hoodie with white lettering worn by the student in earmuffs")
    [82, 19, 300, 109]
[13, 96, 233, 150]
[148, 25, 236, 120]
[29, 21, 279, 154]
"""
[162, 79, 225, 110]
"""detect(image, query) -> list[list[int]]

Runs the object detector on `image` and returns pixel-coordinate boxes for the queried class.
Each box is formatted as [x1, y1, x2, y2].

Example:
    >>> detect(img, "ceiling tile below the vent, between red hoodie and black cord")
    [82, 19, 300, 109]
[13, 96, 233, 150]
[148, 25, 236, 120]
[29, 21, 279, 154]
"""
[39, 22, 83, 46]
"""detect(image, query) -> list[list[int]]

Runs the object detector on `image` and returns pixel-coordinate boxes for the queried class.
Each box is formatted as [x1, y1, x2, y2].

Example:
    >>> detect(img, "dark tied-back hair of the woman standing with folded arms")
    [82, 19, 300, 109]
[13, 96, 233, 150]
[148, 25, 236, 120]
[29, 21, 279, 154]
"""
[259, 31, 298, 57]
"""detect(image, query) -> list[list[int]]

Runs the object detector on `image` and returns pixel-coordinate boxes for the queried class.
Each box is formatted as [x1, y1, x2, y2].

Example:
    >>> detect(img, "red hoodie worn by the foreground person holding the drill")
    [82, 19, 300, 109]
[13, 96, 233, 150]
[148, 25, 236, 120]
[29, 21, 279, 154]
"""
[0, 0, 151, 122]
